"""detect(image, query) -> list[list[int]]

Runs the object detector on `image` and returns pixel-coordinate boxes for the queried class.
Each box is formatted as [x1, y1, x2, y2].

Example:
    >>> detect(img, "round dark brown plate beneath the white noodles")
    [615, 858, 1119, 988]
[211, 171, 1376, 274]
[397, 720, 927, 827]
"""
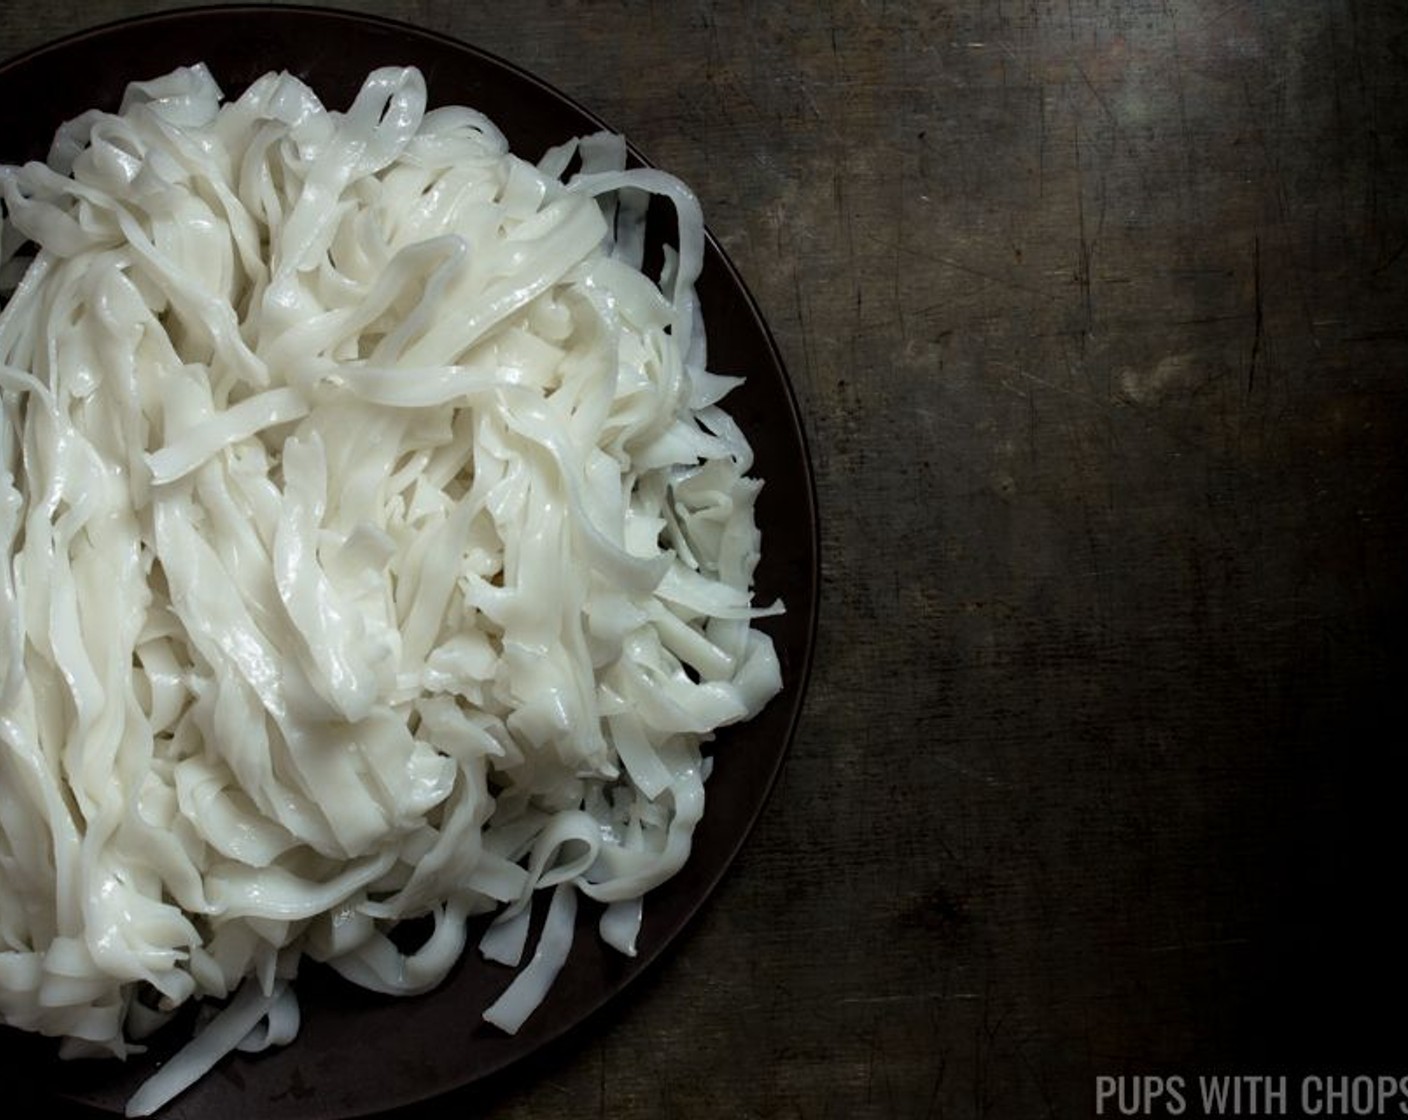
[0, 6, 818, 1120]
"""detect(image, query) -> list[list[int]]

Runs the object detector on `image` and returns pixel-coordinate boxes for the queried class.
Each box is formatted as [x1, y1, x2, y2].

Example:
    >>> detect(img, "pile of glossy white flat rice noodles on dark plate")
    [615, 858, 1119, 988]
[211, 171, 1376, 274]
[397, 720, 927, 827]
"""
[0, 65, 781, 1114]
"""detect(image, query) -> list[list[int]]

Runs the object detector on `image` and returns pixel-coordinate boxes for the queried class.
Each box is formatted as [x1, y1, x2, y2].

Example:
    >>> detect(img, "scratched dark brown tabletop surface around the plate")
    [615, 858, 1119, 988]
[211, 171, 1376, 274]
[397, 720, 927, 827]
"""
[0, 0, 1408, 1120]
